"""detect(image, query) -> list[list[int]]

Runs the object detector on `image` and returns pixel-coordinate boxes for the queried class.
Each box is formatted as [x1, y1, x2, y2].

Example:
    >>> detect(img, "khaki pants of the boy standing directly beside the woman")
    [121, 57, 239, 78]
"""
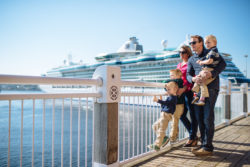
[170, 104, 184, 141]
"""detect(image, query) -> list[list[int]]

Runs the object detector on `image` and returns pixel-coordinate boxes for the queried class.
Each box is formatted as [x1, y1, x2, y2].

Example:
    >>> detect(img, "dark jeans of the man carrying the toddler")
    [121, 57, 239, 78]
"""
[194, 89, 219, 151]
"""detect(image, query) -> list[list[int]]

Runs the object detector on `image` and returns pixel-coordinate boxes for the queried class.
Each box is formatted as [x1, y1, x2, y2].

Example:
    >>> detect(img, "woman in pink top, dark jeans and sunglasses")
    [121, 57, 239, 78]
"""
[177, 45, 198, 147]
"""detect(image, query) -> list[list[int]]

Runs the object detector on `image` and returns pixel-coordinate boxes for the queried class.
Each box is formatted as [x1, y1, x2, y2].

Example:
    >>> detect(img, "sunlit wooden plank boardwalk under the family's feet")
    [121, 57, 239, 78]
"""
[129, 116, 250, 167]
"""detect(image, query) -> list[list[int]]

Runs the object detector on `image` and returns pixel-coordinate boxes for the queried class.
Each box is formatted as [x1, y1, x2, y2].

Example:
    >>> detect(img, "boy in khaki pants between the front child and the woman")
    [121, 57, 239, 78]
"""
[165, 69, 187, 143]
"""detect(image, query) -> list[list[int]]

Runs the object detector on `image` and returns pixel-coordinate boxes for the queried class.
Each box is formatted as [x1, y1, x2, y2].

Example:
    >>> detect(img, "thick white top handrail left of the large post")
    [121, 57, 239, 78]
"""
[0, 74, 102, 86]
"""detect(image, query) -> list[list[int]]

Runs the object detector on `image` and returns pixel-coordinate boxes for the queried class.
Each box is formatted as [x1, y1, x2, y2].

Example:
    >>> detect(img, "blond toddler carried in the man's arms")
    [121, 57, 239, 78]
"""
[192, 35, 220, 106]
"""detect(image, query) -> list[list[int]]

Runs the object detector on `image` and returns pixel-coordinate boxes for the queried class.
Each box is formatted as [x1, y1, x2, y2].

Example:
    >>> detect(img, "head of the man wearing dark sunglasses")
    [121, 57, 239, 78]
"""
[189, 35, 204, 54]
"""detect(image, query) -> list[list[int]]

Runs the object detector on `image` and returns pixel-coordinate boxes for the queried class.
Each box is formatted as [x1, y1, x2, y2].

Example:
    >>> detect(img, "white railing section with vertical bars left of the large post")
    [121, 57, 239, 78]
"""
[0, 75, 102, 166]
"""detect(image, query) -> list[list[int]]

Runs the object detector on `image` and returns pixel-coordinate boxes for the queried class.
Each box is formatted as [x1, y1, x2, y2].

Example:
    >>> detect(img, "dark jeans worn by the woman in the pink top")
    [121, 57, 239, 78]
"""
[181, 91, 198, 140]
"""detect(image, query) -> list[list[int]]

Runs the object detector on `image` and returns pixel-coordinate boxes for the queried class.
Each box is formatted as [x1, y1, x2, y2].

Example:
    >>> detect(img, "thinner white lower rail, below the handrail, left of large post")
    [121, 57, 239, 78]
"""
[0, 93, 102, 100]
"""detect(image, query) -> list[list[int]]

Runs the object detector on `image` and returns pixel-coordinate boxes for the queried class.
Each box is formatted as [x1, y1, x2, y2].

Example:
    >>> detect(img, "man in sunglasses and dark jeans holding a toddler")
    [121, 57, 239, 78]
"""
[187, 35, 226, 155]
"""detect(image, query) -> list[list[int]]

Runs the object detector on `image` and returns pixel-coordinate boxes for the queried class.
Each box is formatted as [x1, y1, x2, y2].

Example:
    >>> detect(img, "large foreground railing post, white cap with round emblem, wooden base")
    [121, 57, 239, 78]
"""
[93, 65, 121, 167]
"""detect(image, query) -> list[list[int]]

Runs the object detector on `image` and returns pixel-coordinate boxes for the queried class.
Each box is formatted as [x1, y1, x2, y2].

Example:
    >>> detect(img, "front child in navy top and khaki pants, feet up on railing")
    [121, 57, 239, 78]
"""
[149, 82, 178, 151]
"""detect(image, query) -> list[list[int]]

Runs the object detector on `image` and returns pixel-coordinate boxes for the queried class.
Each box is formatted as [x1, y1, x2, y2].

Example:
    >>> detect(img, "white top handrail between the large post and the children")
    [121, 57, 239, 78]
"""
[120, 81, 165, 88]
